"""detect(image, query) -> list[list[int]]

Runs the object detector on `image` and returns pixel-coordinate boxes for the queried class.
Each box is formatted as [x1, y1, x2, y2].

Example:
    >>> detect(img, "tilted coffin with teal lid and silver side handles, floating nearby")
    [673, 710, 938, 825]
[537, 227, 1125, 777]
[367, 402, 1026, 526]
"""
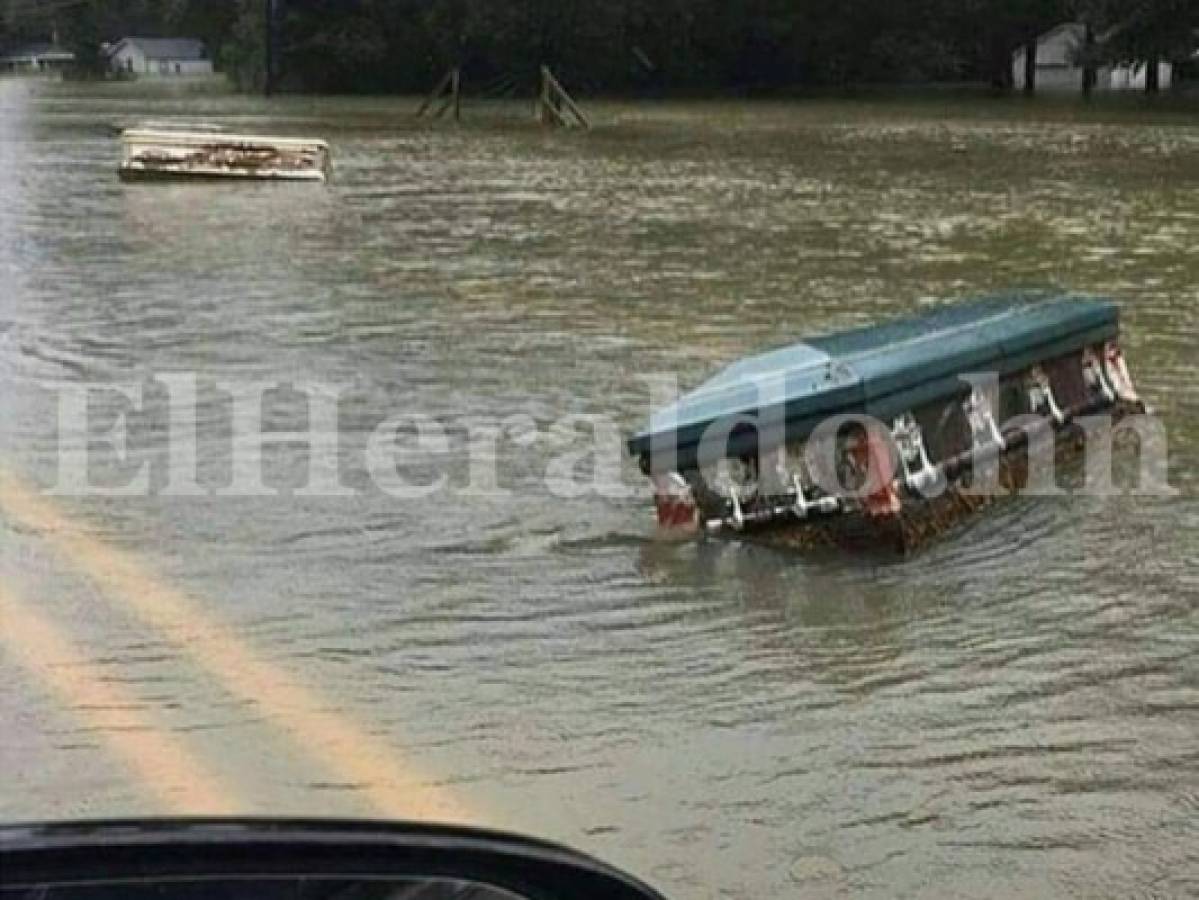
[628, 295, 1140, 549]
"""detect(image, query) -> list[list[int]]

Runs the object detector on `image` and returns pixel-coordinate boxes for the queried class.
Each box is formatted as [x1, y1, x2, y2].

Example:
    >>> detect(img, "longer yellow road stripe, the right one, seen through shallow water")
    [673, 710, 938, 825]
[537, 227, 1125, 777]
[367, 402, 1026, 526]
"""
[0, 471, 488, 825]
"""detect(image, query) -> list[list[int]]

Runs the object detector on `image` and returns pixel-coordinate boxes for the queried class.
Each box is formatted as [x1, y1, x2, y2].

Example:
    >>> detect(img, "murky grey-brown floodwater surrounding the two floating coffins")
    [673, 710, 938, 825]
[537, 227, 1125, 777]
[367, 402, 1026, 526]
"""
[0, 81, 1199, 898]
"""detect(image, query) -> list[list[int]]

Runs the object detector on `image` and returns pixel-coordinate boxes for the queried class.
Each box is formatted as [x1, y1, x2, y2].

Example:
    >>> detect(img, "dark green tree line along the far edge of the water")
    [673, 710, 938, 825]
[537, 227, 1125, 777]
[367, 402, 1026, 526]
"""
[0, 0, 1199, 91]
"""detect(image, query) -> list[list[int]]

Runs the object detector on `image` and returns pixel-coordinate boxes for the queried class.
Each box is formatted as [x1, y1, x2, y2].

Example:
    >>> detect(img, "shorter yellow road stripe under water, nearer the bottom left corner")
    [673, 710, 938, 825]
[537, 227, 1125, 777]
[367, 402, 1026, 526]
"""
[0, 585, 240, 815]
